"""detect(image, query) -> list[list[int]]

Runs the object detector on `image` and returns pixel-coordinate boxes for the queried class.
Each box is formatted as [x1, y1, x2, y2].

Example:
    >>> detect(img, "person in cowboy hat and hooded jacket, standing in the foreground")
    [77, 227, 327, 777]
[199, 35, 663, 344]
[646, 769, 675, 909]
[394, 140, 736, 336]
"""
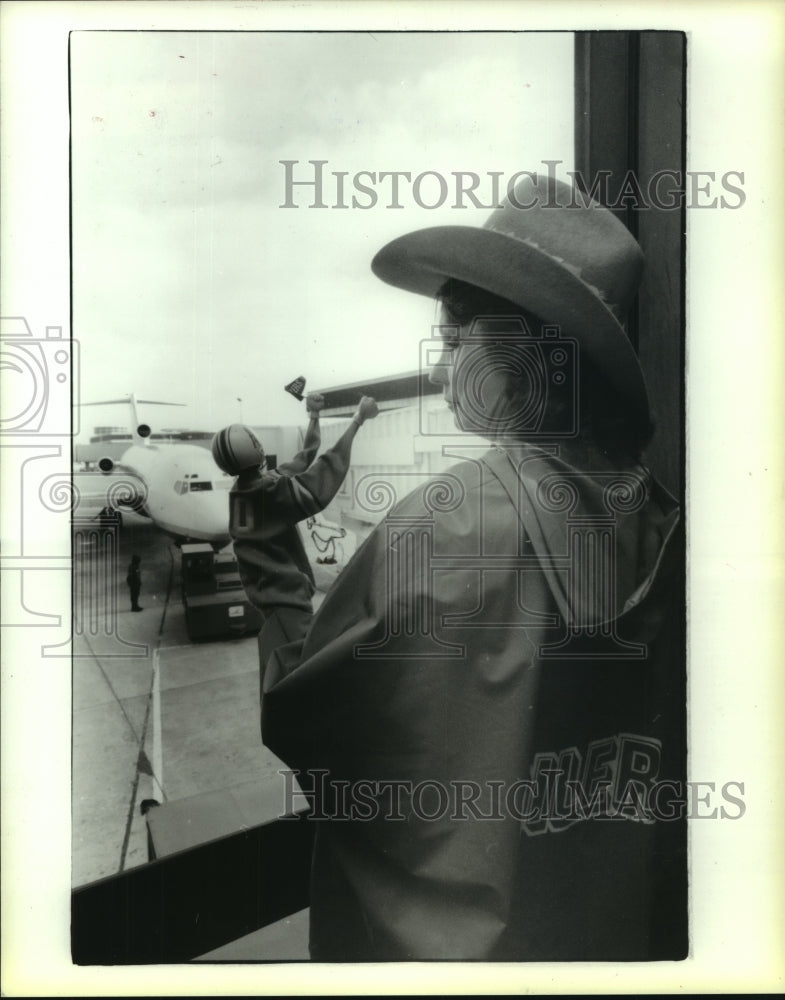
[262, 175, 685, 962]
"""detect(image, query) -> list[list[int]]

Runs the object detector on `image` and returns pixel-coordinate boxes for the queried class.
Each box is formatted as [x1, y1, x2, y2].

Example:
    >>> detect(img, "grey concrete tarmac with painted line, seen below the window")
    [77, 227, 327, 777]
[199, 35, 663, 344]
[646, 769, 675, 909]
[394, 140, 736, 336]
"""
[72, 514, 328, 961]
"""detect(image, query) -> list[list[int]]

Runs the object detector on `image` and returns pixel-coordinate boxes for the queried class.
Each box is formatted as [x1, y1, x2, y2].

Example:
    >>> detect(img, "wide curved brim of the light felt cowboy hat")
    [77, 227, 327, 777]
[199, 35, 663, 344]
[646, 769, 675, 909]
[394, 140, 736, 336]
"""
[371, 226, 649, 421]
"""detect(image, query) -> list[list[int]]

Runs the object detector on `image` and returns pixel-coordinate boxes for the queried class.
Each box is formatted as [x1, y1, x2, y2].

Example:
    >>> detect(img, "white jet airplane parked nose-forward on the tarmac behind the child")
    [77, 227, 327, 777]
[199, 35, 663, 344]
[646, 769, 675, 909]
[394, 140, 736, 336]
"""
[81, 394, 233, 551]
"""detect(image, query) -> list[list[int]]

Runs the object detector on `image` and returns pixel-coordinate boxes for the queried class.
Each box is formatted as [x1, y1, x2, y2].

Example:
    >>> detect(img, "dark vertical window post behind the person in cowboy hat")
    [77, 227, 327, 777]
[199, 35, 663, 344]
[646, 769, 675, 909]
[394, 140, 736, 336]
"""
[575, 31, 688, 958]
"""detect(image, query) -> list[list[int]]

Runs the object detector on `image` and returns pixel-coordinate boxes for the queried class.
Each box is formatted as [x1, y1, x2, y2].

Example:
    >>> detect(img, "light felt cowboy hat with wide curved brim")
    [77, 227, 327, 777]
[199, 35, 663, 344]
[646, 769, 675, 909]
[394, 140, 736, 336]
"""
[371, 173, 649, 420]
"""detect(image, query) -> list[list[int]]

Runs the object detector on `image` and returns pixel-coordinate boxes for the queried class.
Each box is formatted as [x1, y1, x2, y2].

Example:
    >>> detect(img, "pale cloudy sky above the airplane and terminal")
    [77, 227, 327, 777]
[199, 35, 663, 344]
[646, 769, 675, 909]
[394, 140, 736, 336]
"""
[71, 31, 573, 440]
